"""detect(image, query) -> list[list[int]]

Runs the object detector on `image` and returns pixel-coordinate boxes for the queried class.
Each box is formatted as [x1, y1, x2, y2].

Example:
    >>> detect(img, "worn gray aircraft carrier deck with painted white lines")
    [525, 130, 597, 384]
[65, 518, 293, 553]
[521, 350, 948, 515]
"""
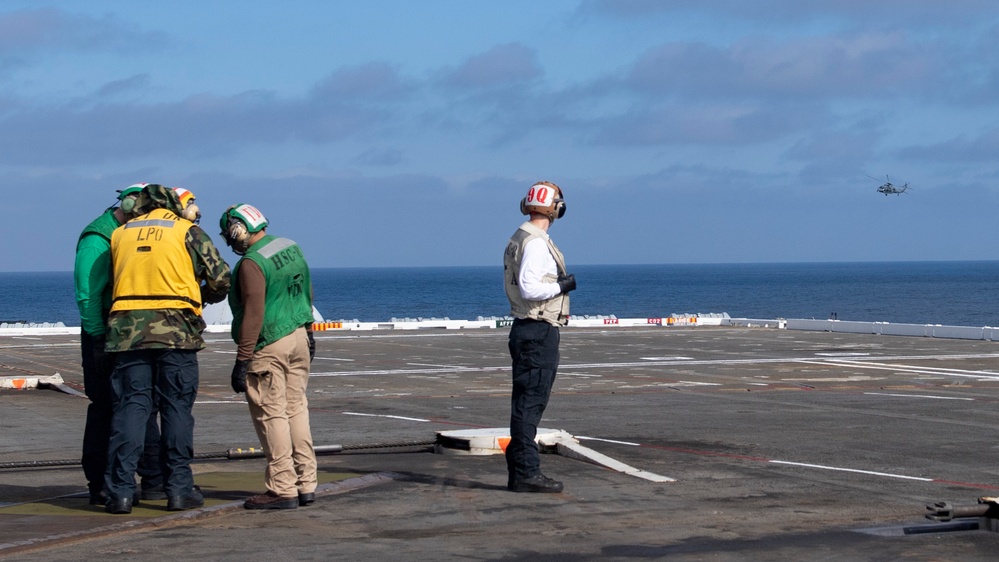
[0, 326, 999, 561]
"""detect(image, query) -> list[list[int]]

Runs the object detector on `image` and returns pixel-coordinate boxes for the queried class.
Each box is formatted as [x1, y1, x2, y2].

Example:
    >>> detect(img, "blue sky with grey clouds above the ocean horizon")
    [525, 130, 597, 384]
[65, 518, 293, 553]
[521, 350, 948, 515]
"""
[0, 0, 999, 271]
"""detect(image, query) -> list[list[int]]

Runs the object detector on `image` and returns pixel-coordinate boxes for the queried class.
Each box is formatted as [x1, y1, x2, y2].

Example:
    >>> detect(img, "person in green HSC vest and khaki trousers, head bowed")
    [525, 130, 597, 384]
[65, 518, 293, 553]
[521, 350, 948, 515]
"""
[219, 204, 316, 509]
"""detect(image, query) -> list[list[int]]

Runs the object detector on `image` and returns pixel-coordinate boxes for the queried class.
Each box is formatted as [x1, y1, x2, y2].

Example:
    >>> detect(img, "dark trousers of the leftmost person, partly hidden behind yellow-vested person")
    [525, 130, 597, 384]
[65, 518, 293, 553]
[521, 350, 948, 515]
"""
[80, 331, 163, 494]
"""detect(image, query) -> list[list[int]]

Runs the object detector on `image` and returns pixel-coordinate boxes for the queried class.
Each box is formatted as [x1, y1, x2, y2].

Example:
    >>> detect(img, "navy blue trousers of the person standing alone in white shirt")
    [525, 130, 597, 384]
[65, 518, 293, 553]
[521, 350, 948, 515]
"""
[506, 319, 559, 482]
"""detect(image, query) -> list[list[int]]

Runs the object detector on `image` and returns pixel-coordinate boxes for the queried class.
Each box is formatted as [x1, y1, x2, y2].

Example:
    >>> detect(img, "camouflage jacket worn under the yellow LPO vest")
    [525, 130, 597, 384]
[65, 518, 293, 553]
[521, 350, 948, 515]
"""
[105, 226, 230, 351]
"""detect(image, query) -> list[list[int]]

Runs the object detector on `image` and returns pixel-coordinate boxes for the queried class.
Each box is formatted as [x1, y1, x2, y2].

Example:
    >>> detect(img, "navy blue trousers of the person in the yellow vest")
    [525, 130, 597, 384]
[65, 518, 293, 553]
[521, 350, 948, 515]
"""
[105, 349, 198, 499]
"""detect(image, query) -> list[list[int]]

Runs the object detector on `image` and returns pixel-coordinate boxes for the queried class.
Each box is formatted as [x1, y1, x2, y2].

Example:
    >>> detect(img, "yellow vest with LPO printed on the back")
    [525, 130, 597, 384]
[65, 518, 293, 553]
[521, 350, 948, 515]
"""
[111, 209, 201, 314]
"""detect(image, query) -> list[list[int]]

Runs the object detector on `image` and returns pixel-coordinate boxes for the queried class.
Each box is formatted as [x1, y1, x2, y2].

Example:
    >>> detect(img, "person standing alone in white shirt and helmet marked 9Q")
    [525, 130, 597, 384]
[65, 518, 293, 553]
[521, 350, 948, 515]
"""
[503, 181, 576, 493]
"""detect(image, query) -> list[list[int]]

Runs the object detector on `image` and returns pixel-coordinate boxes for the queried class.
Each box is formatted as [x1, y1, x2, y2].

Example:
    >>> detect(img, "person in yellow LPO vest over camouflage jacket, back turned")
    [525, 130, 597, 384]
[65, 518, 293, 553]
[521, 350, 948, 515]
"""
[105, 184, 229, 513]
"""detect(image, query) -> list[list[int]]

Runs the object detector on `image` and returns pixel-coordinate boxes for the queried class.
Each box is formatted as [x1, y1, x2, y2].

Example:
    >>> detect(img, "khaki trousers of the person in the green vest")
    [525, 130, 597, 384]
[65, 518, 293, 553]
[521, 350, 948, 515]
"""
[246, 328, 316, 498]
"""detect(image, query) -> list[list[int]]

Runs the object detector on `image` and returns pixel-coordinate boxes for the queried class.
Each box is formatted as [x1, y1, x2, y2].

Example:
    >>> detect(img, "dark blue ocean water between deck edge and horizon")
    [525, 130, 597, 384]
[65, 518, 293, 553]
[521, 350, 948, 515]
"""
[7, 261, 999, 326]
